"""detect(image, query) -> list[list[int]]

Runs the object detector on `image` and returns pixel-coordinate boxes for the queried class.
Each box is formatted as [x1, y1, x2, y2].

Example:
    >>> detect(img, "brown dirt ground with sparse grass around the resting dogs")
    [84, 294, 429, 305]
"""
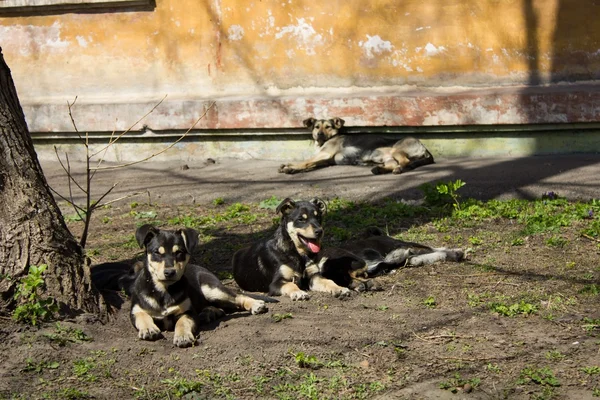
[0, 156, 600, 399]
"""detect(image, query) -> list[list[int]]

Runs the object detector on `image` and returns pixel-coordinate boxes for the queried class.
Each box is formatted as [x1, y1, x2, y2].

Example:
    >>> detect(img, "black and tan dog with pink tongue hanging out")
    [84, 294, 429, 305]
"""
[232, 198, 350, 300]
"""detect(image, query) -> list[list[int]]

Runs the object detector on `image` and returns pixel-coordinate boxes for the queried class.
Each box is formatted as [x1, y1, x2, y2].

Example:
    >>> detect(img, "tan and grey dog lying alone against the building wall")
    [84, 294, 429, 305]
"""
[279, 117, 434, 174]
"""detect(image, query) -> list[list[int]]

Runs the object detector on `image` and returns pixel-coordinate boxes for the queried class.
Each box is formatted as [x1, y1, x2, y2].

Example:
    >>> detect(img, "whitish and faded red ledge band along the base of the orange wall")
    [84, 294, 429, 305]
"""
[22, 82, 600, 135]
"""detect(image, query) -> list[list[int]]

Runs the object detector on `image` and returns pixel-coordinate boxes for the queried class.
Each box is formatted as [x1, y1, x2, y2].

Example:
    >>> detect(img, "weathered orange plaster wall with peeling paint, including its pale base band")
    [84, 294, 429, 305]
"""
[0, 0, 600, 132]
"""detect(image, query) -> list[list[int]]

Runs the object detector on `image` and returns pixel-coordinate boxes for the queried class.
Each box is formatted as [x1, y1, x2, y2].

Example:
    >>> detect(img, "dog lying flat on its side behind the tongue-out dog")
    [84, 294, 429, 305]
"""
[319, 227, 466, 291]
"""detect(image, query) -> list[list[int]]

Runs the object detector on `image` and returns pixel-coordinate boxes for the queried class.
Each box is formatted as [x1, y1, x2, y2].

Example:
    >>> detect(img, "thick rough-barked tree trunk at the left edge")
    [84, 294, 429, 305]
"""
[0, 48, 105, 314]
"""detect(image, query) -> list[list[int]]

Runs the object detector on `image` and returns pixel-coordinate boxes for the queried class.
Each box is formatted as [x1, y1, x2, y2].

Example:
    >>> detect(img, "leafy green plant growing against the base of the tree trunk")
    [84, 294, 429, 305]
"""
[12, 264, 58, 326]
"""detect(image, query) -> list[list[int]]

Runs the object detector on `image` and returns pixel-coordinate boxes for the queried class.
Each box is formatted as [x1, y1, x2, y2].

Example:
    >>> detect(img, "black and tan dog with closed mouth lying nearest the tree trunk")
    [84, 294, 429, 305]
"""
[121, 225, 267, 347]
